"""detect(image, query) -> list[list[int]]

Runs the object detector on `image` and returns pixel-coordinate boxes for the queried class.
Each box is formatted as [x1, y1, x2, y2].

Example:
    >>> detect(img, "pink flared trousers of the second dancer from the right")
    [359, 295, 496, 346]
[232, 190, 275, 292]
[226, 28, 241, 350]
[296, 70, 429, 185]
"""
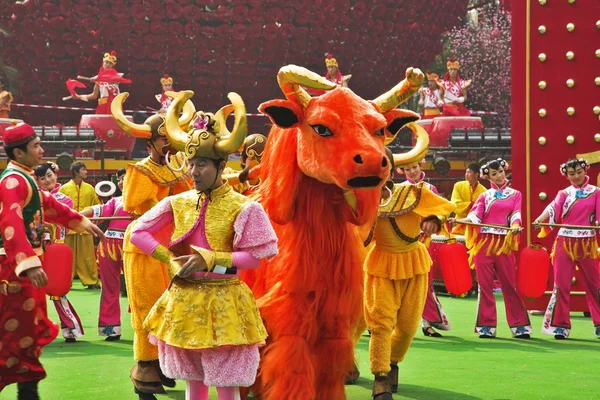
[473, 239, 531, 336]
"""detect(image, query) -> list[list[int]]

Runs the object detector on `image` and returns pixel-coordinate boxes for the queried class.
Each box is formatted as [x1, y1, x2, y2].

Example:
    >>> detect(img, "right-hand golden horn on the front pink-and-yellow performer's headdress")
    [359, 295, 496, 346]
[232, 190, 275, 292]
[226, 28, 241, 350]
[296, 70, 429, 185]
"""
[215, 92, 248, 156]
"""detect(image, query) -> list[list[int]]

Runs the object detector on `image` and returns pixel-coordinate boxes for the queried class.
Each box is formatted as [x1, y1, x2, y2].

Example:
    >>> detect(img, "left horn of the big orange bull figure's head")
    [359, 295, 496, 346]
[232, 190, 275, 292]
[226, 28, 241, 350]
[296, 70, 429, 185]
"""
[277, 65, 337, 107]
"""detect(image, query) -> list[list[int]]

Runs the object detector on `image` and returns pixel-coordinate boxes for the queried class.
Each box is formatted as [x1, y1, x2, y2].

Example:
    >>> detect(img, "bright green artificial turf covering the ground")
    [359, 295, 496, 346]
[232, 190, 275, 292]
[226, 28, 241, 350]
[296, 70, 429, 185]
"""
[0, 282, 600, 400]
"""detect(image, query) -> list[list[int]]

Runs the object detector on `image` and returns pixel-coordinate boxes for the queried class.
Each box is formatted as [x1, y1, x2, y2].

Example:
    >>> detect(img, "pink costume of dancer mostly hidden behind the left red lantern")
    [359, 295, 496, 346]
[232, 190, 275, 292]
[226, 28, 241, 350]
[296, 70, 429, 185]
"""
[43, 183, 84, 339]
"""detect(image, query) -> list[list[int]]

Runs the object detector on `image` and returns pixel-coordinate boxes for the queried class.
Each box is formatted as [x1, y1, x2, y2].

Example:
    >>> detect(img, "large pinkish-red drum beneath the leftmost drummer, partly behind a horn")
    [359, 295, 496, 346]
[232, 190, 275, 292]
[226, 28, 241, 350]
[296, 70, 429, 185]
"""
[79, 114, 135, 159]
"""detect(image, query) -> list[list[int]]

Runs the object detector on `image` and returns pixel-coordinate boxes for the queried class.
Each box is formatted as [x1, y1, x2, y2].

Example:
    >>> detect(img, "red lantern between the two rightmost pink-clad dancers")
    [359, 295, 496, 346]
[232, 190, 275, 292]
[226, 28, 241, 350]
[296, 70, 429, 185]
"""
[517, 243, 550, 299]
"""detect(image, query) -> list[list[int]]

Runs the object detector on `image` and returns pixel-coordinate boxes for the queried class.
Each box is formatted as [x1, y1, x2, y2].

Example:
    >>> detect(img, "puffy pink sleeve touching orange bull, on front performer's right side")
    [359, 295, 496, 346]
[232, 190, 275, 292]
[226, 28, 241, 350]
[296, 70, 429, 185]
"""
[233, 202, 278, 260]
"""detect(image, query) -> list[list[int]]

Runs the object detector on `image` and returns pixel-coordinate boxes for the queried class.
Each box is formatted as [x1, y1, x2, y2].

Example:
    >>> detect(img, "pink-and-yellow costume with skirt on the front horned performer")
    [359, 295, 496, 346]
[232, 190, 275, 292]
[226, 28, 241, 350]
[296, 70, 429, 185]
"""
[131, 184, 277, 398]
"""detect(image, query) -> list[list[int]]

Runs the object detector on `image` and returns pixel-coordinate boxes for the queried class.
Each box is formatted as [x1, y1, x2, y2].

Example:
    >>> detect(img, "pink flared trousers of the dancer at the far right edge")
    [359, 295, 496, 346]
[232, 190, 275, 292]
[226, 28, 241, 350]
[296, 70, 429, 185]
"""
[542, 236, 600, 337]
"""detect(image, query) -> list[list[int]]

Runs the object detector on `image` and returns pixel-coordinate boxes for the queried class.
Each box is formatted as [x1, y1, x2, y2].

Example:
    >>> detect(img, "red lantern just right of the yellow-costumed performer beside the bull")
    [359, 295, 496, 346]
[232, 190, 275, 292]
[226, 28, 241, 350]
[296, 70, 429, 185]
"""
[439, 242, 473, 295]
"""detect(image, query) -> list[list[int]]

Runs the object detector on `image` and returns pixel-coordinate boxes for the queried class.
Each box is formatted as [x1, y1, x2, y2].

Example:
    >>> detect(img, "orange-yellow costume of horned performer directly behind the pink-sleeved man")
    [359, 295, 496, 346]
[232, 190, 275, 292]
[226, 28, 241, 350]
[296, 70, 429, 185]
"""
[123, 153, 191, 361]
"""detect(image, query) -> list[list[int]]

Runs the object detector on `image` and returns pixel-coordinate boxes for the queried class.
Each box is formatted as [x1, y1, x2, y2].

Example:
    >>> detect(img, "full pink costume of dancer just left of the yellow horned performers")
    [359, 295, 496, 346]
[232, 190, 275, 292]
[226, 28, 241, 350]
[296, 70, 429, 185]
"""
[92, 196, 131, 336]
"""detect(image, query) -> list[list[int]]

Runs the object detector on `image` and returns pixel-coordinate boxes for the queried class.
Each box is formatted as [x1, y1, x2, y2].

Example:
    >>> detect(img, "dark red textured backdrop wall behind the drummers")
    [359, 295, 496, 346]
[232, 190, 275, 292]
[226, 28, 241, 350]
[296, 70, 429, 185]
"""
[0, 0, 467, 128]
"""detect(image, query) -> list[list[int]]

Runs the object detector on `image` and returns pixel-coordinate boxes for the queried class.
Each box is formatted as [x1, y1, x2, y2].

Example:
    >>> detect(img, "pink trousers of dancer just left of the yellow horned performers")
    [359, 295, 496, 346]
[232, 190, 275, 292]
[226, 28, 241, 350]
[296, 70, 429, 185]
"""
[98, 239, 123, 336]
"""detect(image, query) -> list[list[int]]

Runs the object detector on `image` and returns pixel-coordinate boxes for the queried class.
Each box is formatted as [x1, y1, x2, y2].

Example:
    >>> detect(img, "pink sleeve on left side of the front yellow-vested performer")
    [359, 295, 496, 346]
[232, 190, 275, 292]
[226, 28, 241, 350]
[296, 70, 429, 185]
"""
[130, 198, 173, 254]
